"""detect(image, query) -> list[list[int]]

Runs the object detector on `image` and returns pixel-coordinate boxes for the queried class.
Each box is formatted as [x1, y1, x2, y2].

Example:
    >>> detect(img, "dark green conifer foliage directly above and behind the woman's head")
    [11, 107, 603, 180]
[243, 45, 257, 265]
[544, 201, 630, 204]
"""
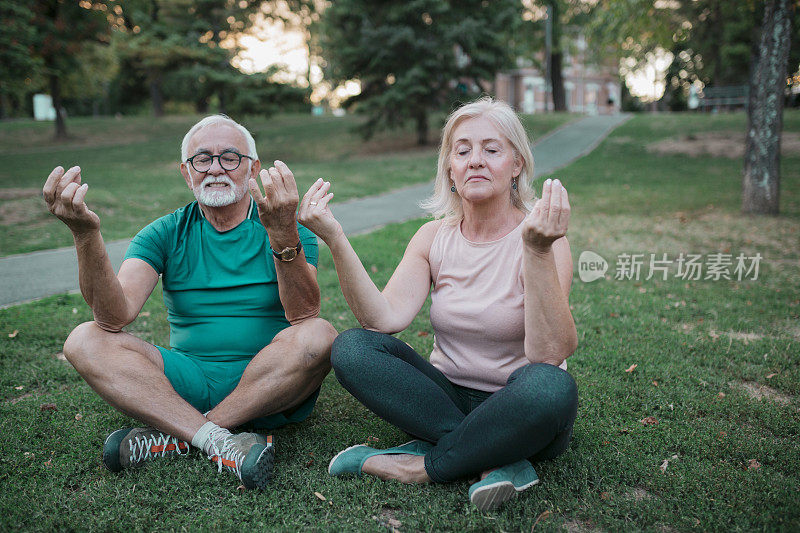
[322, 0, 522, 144]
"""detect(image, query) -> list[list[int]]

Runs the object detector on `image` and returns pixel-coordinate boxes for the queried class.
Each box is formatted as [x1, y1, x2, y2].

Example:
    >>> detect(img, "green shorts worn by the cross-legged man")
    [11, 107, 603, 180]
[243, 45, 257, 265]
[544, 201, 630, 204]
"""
[156, 346, 319, 430]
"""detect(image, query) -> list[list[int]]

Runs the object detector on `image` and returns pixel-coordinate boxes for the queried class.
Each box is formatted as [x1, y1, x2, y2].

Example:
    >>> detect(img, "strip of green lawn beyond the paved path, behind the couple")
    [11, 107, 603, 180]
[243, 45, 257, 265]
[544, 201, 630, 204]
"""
[0, 114, 575, 257]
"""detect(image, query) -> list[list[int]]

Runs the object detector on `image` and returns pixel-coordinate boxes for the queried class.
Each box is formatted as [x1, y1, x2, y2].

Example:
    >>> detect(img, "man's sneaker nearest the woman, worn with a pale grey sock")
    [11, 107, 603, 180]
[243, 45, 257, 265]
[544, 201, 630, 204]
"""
[208, 433, 275, 490]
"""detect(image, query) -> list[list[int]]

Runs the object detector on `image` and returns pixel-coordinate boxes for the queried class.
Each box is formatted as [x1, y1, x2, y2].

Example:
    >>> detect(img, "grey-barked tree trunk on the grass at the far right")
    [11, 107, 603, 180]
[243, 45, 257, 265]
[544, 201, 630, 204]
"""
[742, 0, 793, 215]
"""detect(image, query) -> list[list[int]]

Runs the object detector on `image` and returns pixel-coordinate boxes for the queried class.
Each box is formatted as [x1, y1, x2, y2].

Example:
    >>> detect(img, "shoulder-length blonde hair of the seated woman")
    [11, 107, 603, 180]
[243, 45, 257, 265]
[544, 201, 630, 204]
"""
[420, 96, 536, 223]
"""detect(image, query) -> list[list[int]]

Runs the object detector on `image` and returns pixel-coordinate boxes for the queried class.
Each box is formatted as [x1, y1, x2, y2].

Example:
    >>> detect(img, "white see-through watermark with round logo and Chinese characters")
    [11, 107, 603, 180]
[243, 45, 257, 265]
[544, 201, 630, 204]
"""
[578, 250, 763, 283]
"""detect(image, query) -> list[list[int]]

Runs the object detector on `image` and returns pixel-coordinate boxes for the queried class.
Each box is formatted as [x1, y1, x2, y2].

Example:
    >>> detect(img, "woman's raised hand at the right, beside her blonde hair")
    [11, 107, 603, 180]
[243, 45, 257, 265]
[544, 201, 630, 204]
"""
[522, 179, 570, 252]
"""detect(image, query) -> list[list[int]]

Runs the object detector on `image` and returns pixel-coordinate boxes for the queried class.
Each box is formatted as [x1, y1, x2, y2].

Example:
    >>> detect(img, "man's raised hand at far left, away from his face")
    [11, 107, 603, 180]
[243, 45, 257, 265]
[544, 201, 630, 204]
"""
[42, 166, 100, 235]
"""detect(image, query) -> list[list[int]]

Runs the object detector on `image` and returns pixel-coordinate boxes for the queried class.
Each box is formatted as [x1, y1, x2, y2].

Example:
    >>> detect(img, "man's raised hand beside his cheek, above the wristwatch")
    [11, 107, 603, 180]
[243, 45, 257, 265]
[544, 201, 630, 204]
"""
[248, 161, 300, 231]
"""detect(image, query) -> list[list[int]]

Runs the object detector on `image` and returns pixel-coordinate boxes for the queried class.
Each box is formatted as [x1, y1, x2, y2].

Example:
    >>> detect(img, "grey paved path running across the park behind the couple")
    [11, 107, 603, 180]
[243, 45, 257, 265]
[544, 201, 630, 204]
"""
[0, 115, 629, 308]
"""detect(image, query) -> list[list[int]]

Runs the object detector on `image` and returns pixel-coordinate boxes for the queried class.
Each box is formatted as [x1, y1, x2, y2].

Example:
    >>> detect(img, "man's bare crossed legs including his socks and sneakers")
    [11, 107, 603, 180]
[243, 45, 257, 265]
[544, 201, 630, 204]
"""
[64, 318, 336, 488]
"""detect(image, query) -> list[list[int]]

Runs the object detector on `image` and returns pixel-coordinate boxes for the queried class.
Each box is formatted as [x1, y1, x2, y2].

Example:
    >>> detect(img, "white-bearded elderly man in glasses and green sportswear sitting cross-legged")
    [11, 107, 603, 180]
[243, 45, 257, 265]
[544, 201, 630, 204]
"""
[43, 115, 336, 488]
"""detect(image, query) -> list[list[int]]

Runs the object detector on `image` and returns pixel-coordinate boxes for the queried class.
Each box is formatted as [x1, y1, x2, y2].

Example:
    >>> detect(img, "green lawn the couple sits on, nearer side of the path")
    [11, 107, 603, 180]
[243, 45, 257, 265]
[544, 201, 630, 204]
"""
[0, 112, 800, 531]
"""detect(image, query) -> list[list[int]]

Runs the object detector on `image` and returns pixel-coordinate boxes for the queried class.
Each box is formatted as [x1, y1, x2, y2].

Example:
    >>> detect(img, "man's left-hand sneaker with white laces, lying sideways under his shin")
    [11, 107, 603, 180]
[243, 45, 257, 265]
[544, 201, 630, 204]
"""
[103, 427, 189, 472]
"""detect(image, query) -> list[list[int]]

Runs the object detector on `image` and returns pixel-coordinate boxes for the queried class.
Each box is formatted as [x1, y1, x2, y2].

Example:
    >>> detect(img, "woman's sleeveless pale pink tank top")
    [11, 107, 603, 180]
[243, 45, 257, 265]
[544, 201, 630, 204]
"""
[430, 219, 566, 392]
